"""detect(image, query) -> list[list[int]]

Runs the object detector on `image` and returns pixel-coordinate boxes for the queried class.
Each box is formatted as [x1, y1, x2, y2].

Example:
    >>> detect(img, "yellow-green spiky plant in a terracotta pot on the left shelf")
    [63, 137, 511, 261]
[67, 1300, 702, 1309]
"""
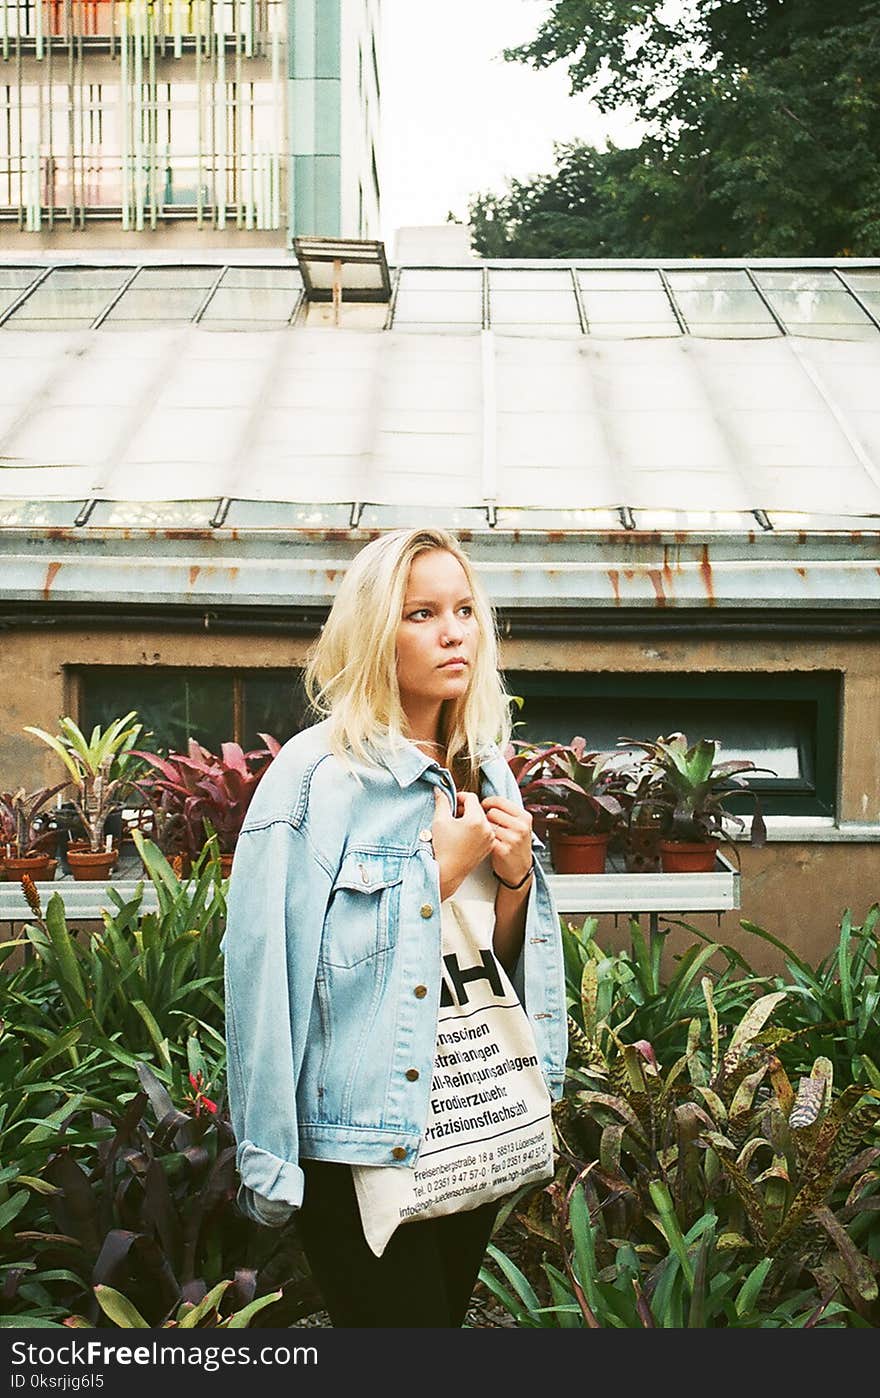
[24, 710, 141, 879]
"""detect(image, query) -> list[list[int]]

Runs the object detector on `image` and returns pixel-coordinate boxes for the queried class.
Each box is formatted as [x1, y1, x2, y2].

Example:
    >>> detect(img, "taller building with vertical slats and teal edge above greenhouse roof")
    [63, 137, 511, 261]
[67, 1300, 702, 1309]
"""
[0, 0, 379, 249]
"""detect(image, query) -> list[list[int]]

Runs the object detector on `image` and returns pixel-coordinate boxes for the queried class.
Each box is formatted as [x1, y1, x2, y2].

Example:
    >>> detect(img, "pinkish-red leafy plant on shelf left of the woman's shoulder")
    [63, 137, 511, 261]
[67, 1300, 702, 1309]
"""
[136, 733, 281, 877]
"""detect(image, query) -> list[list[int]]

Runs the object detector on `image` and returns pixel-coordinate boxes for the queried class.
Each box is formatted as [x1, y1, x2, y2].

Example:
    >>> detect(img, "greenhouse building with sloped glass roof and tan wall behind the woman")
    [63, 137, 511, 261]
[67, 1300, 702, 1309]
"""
[0, 249, 880, 965]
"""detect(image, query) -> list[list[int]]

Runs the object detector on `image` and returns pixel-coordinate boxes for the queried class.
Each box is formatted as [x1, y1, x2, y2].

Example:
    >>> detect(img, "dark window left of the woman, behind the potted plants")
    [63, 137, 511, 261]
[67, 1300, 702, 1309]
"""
[77, 665, 311, 752]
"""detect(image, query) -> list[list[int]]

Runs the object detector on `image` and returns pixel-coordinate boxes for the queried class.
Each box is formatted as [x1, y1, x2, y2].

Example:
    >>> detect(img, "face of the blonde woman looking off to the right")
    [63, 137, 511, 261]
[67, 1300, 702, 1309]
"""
[397, 548, 480, 713]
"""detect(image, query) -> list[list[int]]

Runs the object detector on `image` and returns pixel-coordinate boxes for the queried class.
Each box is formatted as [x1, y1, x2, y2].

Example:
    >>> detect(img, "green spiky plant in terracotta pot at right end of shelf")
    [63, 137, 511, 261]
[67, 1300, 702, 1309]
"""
[620, 733, 775, 874]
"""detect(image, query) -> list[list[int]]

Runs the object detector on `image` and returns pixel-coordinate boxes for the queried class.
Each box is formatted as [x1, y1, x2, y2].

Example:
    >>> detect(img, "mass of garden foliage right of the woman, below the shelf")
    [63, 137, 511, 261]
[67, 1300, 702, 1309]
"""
[481, 910, 880, 1328]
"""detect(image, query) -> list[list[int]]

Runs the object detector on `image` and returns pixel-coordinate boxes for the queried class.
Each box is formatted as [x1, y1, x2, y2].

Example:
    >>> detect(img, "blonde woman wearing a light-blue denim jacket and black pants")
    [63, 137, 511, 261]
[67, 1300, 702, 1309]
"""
[224, 530, 567, 1327]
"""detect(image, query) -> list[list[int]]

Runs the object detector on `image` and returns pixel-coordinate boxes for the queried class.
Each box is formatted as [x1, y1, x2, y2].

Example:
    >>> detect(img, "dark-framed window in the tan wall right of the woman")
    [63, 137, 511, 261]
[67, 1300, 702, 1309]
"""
[506, 671, 839, 815]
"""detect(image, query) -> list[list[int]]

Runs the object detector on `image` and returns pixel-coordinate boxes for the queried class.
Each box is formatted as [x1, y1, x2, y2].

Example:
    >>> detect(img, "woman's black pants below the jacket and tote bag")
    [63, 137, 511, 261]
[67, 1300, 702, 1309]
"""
[298, 1160, 498, 1328]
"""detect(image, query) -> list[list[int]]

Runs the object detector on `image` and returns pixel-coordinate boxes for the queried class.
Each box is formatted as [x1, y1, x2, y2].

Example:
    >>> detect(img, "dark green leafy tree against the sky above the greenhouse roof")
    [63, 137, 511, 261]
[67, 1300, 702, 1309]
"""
[470, 0, 880, 257]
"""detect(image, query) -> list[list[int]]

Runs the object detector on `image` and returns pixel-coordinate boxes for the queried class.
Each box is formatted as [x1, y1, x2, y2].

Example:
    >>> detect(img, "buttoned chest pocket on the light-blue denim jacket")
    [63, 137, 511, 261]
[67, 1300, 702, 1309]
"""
[322, 850, 403, 966]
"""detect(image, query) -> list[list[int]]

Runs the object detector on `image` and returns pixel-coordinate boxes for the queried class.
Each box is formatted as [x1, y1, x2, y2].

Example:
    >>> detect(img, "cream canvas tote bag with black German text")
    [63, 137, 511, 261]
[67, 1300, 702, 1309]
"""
[351, 874, 553, 1257]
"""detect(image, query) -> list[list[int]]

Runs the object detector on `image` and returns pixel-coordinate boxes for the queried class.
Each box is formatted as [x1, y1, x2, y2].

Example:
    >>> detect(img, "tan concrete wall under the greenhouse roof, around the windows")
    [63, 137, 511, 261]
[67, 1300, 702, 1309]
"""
[0, 617, 880, 970]
